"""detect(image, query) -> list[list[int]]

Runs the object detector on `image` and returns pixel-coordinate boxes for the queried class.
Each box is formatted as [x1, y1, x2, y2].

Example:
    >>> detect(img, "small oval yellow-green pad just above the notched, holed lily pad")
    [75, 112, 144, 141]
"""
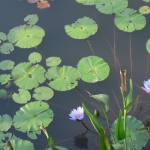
[46, 57, 61, 67]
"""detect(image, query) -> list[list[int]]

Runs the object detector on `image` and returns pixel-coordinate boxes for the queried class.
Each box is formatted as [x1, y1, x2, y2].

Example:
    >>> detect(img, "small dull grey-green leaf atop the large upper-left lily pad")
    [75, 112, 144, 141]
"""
[24, 14, 39, 26]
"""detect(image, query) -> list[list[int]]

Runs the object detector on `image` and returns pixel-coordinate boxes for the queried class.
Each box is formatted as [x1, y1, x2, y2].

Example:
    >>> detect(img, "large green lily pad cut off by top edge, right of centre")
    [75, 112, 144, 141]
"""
[95, 0, 128, 14]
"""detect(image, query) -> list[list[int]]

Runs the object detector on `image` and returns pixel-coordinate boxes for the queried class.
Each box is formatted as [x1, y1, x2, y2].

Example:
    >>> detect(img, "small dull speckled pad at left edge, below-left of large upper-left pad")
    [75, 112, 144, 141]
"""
[0, 43, 14, 54]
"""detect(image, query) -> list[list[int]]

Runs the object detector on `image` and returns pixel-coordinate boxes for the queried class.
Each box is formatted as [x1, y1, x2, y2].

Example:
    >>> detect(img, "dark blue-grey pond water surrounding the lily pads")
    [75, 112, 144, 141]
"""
[0, 0, 150, 150]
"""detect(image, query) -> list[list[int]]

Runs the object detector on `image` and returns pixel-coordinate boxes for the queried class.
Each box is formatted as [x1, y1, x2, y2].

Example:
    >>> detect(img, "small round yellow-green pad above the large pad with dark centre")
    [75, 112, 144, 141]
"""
[28, 52, 42, 64]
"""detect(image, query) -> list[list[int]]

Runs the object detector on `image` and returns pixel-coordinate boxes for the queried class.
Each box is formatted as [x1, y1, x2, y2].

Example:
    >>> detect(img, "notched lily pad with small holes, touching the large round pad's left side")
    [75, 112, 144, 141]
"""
[46, 66, 81, 91]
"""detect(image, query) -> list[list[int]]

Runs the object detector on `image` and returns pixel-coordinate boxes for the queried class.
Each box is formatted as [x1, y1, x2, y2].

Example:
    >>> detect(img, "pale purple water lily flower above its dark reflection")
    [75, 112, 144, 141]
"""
[69, 106, 84, 121]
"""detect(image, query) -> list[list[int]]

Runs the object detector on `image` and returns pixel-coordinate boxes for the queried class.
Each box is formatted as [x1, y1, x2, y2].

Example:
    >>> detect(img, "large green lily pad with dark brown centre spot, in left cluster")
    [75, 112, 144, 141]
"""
[12, 62, 46, 90]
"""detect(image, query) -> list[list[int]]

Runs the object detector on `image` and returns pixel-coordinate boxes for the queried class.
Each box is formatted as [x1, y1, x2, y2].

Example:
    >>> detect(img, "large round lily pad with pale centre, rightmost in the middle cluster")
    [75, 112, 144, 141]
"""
[77, 56, 110, 83]
